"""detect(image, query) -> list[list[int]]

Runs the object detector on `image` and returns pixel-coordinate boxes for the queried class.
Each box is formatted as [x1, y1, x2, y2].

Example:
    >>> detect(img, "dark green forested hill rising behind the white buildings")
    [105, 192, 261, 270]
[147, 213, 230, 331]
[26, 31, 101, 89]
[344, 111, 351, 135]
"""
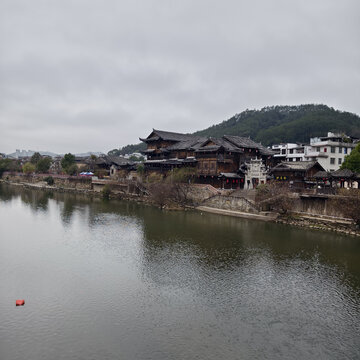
[194, 105, 360, 145]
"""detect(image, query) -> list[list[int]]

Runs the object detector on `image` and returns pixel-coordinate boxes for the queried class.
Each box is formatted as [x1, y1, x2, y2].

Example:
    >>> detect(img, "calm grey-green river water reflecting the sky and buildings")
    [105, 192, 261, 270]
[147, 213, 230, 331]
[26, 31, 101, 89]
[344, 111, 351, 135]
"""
[0, 185, 360, 360]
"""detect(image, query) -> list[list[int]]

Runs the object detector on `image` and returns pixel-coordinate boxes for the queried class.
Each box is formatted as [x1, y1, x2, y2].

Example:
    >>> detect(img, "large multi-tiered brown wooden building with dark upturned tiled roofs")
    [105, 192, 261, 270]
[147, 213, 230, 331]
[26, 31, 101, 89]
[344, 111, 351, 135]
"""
[140, 129, 273, 188]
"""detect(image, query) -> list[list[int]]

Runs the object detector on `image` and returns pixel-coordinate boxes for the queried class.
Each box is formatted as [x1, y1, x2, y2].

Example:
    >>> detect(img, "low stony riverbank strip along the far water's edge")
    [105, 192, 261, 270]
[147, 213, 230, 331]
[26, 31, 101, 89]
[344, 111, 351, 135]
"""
[0, 179, 360, 237]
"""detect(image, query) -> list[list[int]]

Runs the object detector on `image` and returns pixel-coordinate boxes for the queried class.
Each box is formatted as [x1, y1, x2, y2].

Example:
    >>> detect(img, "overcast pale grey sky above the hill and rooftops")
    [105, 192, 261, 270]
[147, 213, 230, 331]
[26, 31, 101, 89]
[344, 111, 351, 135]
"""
[0, 0, 360, 153]
